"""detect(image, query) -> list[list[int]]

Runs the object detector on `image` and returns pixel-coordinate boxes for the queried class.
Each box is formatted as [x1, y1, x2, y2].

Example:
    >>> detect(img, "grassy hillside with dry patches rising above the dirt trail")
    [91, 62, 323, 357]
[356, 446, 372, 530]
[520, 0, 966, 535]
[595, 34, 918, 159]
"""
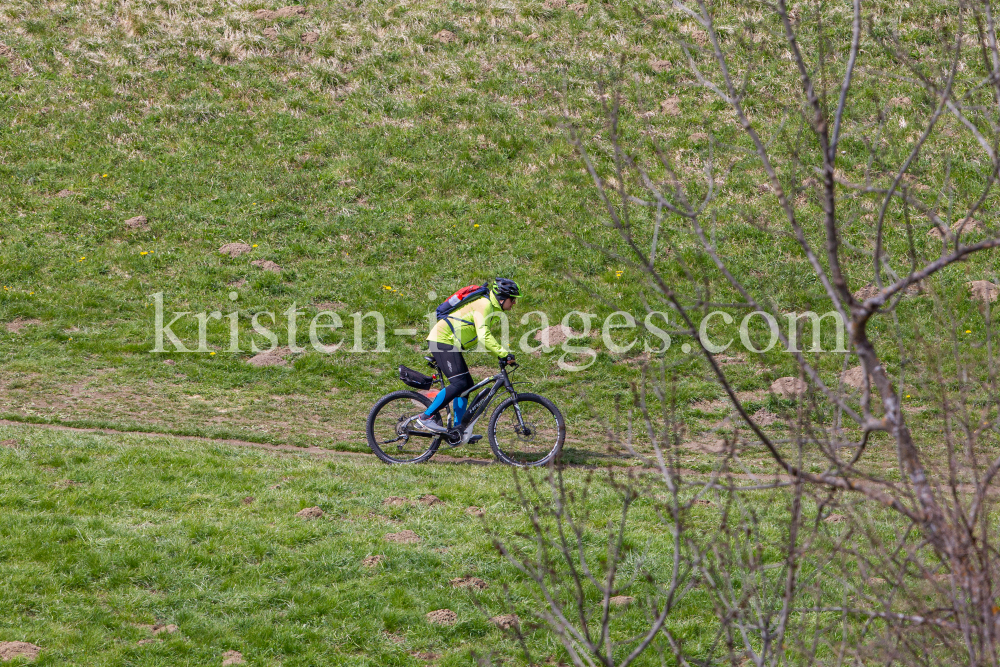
[0, 0, 994, 470]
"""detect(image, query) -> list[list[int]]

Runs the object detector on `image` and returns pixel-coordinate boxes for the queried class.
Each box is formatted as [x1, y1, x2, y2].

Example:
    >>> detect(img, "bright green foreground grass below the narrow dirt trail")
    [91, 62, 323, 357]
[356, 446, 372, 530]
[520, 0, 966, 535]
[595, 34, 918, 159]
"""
[0, 426, 736, 666]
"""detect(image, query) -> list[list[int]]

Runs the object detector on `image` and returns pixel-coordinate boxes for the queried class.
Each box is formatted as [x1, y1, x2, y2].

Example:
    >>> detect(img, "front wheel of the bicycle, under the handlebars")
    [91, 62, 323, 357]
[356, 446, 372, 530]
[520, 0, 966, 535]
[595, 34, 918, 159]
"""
[487, 394, 566, 467]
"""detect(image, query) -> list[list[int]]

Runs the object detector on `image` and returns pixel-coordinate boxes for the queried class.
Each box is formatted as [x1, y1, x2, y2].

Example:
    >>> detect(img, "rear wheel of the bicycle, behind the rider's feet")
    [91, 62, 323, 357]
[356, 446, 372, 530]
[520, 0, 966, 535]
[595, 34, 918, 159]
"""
[366, 391, 448, 463]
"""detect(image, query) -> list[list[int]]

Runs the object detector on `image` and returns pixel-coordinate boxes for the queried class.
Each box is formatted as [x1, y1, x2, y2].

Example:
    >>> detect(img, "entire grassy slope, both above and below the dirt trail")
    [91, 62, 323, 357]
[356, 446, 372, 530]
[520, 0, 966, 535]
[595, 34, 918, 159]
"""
[0, 0, 998, 665]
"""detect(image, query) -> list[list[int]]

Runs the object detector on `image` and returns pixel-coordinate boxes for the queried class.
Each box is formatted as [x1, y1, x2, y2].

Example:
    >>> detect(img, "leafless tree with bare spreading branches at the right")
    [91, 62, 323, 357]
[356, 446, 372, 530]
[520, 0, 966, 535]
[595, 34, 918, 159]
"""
[505, 0, 1000, 665]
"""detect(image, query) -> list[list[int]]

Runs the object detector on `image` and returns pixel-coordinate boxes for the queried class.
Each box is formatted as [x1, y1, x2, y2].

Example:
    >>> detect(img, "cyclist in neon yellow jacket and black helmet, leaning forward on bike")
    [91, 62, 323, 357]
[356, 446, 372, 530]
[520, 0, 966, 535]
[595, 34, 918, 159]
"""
[416, 278, 521, 433]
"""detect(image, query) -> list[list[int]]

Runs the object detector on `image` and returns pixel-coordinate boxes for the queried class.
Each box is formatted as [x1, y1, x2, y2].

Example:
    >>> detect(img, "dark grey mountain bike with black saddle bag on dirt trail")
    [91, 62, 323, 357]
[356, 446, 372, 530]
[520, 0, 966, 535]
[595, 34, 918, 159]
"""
[366, 356, 566, 467]
